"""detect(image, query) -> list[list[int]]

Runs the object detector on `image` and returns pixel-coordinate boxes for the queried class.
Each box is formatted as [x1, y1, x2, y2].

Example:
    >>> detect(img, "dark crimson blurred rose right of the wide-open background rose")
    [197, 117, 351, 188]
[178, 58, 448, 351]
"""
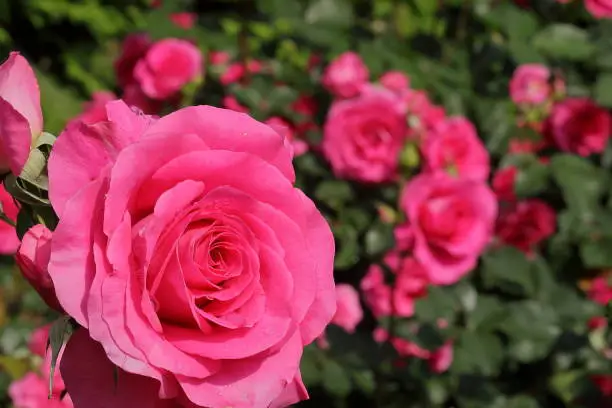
[496, 198, 557, 253]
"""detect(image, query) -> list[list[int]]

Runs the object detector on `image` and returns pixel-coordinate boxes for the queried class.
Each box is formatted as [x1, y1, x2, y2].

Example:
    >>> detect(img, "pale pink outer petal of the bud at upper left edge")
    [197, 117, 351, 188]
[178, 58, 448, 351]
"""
[0, 52, 43, 135]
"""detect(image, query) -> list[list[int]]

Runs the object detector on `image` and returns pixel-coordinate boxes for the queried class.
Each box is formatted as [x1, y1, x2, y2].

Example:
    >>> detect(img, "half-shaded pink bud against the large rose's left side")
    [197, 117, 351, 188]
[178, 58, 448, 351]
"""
[15, 224, 63, 312]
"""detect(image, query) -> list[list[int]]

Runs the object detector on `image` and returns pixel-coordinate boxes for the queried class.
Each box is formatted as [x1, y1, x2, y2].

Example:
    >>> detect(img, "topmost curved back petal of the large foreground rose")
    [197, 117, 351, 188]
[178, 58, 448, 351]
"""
[147, 106, 295, 183]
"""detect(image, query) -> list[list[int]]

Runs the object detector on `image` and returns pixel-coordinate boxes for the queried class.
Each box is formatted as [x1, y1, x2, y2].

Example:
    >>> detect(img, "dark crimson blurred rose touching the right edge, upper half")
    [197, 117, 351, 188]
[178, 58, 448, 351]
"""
[545, 98, 610, 157]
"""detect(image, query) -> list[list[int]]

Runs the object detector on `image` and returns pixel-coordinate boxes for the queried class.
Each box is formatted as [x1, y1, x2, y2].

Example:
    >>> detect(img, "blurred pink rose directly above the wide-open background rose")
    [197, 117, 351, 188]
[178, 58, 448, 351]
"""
[421, 117, 490, 181]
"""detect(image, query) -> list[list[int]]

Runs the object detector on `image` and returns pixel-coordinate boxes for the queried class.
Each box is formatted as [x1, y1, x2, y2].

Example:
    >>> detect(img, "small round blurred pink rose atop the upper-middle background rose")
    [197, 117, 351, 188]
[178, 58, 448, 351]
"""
[322, 51, 370, 98]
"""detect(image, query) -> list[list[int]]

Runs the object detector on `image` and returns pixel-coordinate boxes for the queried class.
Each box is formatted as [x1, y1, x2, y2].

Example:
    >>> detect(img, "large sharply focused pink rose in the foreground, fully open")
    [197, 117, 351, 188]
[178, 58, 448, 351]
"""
[49, 101, 336, 408]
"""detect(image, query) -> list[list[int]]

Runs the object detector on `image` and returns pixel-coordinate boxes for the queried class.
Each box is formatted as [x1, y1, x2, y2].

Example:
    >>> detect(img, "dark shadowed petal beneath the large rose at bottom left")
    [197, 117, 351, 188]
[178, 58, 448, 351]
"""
[60, 329, 181, 408]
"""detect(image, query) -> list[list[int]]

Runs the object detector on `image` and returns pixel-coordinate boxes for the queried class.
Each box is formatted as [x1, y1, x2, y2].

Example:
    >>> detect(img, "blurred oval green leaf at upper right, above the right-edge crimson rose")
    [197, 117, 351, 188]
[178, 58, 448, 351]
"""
[533, 23, 595, 61]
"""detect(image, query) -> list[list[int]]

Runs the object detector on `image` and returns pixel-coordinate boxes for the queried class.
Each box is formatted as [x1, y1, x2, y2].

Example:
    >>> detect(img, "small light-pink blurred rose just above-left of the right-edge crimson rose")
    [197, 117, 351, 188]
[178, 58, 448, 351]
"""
[510, 64, 552, 105]
